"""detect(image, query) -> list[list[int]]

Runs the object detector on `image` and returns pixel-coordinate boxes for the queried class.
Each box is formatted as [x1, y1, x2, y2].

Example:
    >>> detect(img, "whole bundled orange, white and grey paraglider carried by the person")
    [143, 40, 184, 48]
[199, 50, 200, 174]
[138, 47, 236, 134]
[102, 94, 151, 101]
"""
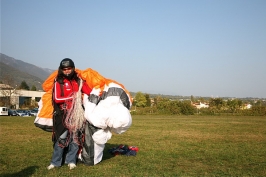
[34, 68, 133, 165]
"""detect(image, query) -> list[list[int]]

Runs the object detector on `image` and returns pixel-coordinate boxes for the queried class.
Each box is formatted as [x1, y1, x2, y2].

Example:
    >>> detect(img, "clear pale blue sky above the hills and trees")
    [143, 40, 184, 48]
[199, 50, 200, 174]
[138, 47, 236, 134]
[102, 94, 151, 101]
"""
[1, 0, 266, 98]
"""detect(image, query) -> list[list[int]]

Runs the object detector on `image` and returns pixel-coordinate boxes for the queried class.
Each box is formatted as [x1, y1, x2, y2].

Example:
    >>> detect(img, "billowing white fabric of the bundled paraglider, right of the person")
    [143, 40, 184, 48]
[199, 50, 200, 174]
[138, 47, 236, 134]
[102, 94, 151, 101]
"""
[83, 84, 132, 165]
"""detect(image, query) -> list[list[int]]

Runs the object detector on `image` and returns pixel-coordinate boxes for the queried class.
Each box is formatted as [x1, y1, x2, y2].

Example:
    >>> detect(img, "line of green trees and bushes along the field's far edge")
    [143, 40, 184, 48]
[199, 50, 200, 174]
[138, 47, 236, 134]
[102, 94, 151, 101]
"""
[131, 92, 266, 116]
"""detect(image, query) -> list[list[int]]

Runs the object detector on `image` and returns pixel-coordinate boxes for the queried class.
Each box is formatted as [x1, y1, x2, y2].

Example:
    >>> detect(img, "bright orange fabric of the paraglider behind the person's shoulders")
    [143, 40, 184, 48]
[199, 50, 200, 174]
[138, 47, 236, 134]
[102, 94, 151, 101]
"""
[38, 68, 133, 119]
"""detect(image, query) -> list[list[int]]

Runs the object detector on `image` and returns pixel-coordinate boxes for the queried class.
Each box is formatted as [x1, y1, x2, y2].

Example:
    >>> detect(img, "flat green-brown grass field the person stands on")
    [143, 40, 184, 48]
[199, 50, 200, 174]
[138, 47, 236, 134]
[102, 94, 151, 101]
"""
[0, 116, 266, 177]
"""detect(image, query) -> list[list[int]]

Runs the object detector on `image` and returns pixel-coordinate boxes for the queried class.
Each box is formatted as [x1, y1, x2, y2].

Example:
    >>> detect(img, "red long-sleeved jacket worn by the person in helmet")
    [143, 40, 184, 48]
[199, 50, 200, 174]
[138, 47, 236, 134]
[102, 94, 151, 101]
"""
[54, 79, 92, 104]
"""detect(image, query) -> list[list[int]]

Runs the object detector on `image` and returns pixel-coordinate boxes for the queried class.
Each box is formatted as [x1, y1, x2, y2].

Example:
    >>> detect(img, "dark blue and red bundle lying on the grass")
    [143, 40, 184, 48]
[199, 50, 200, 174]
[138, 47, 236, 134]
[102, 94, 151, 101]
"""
[108, 144, 139, 156]
